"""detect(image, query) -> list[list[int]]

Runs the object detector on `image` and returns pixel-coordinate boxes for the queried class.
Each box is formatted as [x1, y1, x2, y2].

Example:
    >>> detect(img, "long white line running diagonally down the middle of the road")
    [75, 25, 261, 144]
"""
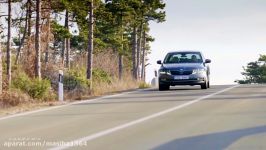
[49, 85, 240, 150]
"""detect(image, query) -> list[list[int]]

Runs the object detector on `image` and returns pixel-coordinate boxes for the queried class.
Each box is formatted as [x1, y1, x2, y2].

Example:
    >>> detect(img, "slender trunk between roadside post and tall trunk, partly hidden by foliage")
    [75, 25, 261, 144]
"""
[64, 10, 70, 69]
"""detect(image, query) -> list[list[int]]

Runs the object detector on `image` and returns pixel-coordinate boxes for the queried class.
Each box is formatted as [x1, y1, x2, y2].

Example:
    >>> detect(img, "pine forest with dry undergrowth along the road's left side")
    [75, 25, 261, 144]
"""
[0, 0, 166, 107]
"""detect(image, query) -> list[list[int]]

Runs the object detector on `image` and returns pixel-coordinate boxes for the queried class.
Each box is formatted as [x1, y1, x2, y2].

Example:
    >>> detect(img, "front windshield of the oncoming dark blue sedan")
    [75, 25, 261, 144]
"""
[164, 52, 203, 64]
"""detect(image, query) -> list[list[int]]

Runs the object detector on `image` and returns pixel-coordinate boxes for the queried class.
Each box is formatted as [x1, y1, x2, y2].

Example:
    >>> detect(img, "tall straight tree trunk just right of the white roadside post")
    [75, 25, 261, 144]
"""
[87, 0, 94, 89]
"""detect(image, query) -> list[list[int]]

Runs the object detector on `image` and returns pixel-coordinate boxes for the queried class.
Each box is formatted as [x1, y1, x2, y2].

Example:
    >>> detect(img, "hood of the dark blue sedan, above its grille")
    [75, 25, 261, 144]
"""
[161, 63, 204, 70]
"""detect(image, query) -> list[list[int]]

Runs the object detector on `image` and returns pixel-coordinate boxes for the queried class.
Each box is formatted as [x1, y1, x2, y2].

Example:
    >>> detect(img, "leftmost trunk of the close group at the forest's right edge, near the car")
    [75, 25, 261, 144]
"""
[132, 26, 137, 80]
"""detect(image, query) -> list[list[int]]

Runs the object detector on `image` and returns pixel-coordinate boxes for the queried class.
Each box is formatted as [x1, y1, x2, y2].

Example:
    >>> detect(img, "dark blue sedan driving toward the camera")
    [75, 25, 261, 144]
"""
[157, 51, 211, 91]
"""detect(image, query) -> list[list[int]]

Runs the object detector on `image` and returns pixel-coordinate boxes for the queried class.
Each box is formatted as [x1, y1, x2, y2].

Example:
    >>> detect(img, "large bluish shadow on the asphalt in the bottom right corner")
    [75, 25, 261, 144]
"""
[153, 126, 266, 150]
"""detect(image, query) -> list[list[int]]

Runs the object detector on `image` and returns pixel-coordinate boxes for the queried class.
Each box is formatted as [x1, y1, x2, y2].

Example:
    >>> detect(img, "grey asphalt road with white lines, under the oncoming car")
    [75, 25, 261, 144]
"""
[0, 85, 266, 150]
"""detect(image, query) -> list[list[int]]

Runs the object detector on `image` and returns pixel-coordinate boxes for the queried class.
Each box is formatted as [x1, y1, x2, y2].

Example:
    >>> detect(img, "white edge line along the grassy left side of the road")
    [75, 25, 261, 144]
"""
[0, 89, 141, 121]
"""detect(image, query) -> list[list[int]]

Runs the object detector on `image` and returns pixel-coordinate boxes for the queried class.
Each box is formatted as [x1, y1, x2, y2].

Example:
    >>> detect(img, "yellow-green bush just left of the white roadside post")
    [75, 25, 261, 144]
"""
[12, 72, 51, 100]
